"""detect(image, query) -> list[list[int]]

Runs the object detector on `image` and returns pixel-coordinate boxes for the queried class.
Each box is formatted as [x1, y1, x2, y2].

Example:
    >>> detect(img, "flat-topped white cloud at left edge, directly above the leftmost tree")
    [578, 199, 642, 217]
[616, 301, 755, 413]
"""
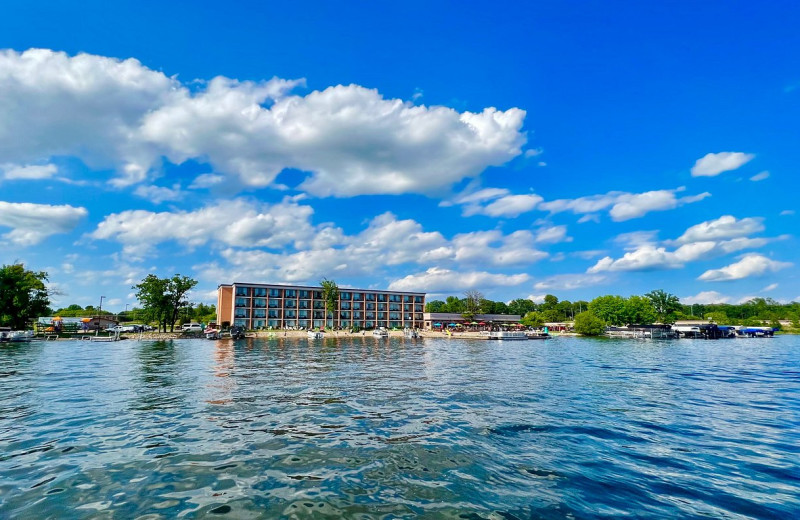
[0, 201, 89, 246]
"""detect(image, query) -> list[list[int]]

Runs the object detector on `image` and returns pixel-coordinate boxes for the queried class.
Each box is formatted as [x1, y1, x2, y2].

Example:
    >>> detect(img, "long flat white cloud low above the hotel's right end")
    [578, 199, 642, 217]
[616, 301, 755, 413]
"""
[389, 267, 530, 294]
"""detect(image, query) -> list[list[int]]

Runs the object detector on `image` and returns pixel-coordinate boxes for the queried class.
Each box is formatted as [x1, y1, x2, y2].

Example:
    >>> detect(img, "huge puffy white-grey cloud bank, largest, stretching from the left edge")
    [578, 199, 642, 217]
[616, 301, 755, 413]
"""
[0, 49, 526, 197]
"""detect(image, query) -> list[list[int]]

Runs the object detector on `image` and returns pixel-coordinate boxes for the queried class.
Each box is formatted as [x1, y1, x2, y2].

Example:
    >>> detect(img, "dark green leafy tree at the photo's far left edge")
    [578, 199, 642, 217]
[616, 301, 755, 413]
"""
[0, 264, 50, 329]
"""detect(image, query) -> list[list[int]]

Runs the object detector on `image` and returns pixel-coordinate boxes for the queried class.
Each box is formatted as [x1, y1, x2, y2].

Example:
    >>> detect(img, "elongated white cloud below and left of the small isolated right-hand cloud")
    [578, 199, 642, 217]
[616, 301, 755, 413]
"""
[538, 187, 711, 222]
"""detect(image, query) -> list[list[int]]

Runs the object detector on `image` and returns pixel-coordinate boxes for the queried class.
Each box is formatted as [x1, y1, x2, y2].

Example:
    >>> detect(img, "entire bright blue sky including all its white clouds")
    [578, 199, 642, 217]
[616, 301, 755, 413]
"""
[0, 1, 800, 310]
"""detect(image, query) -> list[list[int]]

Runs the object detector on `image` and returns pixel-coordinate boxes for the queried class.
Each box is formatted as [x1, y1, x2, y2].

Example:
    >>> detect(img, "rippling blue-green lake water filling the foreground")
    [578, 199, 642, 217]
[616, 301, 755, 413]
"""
[0, 336, 800, 519]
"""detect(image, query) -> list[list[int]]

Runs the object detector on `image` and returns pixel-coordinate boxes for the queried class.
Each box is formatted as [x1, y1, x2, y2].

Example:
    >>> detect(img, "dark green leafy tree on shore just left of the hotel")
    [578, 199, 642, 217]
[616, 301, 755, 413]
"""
[133, 274, 197, 332]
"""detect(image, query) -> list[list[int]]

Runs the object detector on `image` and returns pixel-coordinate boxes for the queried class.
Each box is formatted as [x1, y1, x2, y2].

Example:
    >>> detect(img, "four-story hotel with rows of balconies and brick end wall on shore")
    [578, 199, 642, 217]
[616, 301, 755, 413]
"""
[212, 282, 425, 329]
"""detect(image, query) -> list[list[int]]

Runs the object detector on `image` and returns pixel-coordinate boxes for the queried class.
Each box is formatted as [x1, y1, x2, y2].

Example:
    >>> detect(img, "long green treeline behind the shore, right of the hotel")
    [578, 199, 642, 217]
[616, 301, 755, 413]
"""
[425, 289, 800, 328]
